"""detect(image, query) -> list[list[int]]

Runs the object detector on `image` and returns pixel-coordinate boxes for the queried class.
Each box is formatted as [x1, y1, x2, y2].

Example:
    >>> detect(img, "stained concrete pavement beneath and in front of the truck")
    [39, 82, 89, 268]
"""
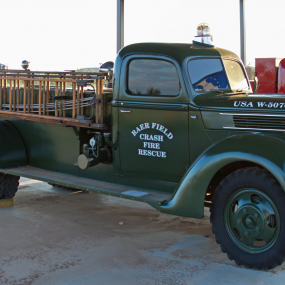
[0, 179, 285, 285]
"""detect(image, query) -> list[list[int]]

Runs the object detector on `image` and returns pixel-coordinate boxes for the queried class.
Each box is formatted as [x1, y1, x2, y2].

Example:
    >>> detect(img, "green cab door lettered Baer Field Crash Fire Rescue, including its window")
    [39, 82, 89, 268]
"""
[118, 55, 189, 182]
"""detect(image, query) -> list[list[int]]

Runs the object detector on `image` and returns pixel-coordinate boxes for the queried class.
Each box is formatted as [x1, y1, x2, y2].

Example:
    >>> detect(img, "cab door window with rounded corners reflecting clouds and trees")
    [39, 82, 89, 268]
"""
[128, 59, 181, 96]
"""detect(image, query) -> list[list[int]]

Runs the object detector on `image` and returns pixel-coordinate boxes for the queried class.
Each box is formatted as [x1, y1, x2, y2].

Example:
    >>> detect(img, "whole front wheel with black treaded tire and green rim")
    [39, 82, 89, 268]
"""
[210, 168, 285, 270]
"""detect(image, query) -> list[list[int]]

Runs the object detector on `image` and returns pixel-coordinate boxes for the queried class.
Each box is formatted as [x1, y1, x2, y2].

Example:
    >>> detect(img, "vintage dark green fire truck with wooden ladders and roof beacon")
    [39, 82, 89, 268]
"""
[0, 26, 285, 269]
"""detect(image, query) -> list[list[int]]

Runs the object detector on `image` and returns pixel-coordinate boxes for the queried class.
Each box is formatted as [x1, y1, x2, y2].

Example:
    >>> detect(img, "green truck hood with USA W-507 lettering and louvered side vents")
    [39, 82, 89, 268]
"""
[195, 93, 285, 133]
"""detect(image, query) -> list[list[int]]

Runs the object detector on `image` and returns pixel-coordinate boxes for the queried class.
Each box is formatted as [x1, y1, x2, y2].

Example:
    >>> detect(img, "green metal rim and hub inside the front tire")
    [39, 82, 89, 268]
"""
[225, 189, 280, 253]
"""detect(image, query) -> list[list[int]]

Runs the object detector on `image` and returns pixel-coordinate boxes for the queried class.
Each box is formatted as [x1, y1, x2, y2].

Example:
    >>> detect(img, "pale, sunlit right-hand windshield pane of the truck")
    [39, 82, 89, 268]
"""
[223, 60, 249, 90]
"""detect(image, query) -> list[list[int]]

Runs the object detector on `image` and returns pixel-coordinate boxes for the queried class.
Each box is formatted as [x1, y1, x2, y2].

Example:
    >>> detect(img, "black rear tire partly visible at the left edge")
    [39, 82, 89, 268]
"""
[0, 173, 20, 199]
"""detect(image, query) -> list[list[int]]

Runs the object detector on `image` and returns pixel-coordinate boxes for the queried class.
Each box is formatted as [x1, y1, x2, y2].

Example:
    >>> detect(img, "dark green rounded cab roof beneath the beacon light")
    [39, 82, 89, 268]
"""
[118, 43, 239, 65]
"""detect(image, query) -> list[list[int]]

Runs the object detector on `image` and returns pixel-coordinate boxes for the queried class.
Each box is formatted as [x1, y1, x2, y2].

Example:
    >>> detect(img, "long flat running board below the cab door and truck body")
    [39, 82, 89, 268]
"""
[0, 166, 172, 205]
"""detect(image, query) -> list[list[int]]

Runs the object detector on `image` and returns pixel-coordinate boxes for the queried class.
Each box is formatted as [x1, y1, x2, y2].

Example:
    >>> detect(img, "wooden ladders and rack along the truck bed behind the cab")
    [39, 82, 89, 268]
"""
[0, 69, 110, 130]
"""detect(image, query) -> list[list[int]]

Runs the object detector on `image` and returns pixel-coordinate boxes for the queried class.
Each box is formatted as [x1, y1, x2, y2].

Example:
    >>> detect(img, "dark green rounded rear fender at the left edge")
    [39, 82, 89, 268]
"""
[0, 121, 28, 169]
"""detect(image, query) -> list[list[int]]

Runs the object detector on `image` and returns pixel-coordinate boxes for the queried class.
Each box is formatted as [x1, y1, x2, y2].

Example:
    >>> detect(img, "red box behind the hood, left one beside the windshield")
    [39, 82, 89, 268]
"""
[255, 58, 281, 93]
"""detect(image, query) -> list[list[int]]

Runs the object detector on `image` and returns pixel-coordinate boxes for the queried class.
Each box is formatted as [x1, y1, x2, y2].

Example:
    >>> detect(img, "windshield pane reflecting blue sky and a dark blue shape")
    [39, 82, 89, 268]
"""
[188, 58, 229, 92]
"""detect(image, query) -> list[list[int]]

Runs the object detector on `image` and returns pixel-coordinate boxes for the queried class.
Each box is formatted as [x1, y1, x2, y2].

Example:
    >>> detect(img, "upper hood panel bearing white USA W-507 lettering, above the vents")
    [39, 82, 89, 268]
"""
[194, 91, 285, 112]
